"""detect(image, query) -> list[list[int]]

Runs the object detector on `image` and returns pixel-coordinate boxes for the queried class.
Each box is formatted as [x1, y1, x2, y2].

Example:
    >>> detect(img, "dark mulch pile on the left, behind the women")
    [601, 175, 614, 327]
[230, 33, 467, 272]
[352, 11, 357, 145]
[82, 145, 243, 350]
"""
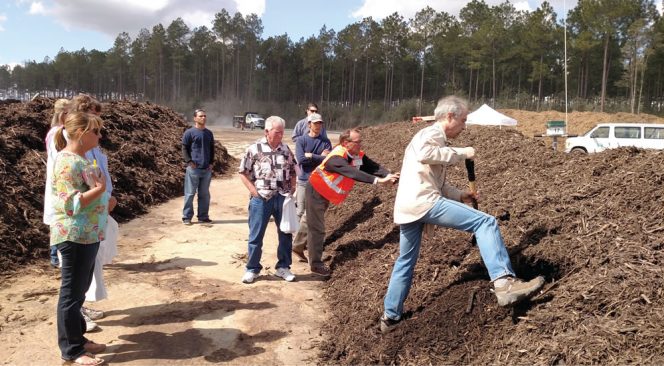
[0, 98, 235, 272]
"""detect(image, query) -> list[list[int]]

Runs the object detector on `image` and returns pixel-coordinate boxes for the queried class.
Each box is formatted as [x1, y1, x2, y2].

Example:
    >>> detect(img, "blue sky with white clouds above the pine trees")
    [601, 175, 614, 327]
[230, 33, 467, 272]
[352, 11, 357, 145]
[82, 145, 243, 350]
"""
[0, 0, 662, 65]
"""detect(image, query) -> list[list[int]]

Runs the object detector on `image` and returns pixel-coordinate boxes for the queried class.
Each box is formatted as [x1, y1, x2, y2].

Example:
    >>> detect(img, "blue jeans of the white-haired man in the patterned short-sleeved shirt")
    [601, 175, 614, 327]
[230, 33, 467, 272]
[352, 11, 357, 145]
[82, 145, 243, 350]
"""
[247, 193, 293, 273]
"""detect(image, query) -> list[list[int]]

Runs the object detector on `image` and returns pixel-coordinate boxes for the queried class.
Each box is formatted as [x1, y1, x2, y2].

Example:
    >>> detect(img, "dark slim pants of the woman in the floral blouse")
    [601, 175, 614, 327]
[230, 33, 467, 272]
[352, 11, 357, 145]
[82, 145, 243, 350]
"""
[57, 241, 99, 360]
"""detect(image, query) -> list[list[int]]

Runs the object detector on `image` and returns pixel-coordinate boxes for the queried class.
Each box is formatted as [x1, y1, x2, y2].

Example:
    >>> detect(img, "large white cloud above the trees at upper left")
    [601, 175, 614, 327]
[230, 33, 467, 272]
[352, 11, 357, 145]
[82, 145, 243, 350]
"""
[50, 0, 254, 37]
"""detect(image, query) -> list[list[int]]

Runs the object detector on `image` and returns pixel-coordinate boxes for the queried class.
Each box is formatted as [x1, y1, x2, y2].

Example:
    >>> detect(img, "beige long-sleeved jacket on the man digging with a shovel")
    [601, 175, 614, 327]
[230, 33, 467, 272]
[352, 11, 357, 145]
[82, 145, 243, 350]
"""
[394, 123, 466, 224]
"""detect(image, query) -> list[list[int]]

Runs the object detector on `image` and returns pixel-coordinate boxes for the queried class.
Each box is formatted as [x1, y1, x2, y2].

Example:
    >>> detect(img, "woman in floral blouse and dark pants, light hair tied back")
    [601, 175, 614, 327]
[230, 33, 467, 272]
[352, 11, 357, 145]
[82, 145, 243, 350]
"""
[50, 112, 109, 365]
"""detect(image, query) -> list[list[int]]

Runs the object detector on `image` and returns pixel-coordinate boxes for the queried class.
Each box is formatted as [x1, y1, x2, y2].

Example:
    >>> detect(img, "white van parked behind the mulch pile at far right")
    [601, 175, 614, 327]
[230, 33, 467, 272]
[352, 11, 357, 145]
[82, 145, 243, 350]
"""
[565, 123, 664, 153]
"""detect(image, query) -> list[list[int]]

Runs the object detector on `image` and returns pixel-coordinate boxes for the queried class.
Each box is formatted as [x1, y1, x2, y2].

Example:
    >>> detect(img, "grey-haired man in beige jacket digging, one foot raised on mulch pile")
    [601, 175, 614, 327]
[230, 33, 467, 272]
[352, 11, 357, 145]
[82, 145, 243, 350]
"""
[380, 96, 544, 333]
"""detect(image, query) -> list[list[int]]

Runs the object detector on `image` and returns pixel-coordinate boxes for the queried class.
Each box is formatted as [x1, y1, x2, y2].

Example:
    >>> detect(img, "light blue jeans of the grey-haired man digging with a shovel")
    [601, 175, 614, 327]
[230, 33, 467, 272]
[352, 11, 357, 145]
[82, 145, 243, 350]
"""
[384, 198, 514, 320]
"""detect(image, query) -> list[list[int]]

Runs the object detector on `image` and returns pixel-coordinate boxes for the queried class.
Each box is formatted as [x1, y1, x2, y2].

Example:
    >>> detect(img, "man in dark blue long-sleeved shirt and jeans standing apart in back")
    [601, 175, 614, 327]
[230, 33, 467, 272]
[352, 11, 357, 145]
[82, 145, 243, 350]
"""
[182, 109, 214, 225]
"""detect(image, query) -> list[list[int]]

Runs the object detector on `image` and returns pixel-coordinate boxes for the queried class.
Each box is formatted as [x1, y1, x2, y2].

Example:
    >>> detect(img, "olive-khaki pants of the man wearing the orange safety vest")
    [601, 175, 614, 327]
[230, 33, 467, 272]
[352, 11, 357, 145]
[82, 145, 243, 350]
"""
[298, 184, 330, 267]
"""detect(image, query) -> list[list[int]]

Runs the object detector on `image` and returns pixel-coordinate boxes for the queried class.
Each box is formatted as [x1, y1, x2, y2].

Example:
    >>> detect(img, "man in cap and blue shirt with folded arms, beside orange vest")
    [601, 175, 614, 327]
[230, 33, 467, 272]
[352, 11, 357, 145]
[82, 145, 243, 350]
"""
[293, 113, 332, 262]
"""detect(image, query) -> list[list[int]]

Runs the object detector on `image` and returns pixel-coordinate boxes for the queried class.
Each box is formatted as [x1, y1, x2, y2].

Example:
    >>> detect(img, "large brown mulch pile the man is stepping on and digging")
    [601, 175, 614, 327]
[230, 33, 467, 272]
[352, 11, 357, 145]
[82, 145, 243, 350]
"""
[321, 121, 664, 364]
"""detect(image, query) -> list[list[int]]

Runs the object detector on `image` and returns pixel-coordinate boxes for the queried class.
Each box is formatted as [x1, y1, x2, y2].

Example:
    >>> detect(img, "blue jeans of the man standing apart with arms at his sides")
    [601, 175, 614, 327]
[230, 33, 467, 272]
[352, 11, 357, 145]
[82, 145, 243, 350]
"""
[182, 166, 212, 220]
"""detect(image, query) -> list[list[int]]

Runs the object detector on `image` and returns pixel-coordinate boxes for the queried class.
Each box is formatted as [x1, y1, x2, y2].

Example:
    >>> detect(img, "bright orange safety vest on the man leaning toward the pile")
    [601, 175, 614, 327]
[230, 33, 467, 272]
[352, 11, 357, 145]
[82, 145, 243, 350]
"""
[309, 145, 364, 205]
